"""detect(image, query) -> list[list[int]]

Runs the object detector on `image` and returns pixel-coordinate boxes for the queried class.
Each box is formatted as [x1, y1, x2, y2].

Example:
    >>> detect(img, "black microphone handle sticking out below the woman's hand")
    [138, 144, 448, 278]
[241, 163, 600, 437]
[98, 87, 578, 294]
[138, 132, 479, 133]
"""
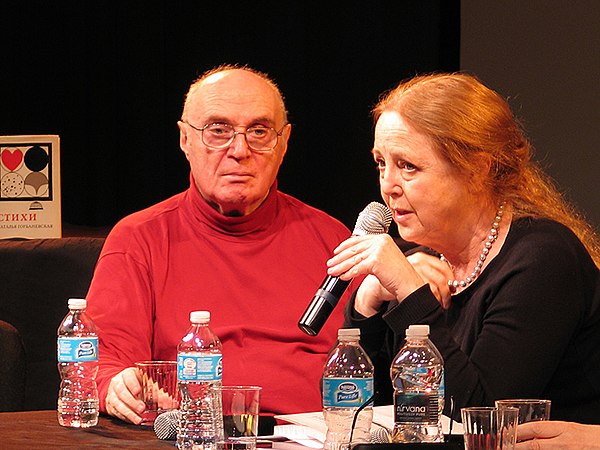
[298, 275, 350, 336]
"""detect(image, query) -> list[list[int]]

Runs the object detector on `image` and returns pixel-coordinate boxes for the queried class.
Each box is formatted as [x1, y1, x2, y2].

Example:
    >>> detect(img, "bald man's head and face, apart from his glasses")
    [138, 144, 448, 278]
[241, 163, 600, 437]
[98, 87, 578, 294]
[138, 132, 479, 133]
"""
[179, 70, 291, 216]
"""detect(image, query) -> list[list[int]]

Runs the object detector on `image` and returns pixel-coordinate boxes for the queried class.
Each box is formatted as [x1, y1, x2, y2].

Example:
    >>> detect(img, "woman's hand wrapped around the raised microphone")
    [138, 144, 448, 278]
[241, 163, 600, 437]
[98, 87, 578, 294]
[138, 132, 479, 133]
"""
[327, 234, 425, 317]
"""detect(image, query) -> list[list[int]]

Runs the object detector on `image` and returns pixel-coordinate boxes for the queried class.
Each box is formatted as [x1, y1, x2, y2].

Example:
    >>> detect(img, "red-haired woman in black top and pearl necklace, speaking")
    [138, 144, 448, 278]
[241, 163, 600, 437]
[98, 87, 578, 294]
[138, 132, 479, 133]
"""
[328, 73, 600, 423]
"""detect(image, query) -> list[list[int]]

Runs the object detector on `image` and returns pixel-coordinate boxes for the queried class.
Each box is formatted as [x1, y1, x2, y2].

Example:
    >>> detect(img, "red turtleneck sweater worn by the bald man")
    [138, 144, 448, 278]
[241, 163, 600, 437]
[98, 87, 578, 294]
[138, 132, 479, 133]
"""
[87, 180, 351, 414]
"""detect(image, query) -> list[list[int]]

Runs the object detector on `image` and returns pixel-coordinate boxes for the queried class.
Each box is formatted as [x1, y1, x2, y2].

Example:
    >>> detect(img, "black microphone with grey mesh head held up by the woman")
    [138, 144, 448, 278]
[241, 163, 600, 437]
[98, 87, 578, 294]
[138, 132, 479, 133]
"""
[298, 202, 392, 336]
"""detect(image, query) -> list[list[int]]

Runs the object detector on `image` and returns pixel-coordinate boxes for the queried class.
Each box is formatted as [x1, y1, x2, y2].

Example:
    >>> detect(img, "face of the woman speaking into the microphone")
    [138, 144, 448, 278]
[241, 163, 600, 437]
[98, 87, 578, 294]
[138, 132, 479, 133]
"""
[373, 111, 474, 250]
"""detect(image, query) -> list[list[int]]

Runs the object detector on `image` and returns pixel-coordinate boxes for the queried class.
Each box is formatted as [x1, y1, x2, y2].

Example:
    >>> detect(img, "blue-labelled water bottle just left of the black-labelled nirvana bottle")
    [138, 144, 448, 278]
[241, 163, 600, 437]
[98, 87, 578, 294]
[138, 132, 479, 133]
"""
[322, 328, 373, 450]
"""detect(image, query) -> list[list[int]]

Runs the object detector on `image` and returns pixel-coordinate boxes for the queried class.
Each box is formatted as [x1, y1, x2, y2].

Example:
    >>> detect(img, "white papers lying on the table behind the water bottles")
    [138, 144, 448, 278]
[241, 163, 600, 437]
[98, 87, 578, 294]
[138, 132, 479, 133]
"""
[275, 405, 463, 442]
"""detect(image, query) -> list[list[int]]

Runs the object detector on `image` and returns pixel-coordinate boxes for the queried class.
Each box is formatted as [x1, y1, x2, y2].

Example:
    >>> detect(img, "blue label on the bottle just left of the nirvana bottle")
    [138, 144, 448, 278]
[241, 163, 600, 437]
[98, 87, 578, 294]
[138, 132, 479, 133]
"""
[323, 377, 373, 407]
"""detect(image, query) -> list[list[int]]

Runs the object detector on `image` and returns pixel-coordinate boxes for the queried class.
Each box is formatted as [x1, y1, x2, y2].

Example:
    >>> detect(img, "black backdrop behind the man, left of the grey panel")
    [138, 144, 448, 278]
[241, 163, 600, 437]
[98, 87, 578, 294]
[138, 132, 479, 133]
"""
[0, 0, 460, 229]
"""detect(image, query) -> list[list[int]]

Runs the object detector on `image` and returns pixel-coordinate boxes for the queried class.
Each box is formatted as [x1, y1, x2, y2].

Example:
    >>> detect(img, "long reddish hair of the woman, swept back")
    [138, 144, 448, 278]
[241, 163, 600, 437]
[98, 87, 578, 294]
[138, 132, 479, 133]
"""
[373, 73, 600, 267]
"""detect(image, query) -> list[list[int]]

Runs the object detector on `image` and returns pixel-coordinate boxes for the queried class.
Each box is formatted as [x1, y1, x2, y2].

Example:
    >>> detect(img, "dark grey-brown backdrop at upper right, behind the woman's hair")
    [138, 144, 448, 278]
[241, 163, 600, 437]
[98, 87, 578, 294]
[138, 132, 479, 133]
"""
[460, 0, 600, 229]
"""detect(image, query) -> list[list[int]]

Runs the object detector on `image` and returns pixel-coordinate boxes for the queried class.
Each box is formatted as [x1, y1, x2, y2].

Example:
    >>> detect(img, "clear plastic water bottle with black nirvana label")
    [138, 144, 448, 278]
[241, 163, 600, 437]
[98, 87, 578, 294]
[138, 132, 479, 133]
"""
[390, 325, 444, 442]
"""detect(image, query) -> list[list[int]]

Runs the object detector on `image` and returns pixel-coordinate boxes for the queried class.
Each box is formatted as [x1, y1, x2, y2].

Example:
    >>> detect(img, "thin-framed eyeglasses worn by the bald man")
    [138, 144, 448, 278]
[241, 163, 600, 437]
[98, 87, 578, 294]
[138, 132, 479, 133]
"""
[182, 120, 287, 153]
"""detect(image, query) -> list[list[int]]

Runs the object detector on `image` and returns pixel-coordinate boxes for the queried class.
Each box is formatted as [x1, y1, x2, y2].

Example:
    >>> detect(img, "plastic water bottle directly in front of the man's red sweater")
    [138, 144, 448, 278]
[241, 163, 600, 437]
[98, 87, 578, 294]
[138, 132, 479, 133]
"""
[177, 311, 223, 450]
